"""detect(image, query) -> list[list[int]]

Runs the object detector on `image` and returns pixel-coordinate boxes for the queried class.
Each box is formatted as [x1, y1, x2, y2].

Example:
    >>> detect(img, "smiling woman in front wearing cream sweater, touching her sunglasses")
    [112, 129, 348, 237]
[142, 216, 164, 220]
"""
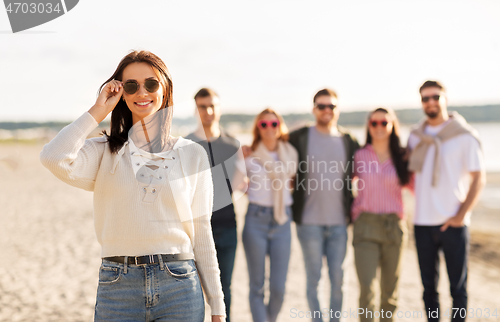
[40, 51, 225, 322]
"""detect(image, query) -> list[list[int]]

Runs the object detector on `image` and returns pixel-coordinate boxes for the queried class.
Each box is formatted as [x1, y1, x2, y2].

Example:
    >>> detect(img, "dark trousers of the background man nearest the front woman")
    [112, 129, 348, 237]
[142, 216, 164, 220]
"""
[212, 227, 237, 322]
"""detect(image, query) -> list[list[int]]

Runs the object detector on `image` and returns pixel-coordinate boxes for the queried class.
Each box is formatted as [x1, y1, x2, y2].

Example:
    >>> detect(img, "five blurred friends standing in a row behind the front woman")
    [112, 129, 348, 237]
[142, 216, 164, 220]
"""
[187, 81, 485, 322]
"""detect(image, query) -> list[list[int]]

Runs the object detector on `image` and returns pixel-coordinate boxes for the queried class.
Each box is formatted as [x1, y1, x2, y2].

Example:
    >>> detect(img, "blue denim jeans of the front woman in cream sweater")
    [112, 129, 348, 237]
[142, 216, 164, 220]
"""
[94, 260, 205, 322]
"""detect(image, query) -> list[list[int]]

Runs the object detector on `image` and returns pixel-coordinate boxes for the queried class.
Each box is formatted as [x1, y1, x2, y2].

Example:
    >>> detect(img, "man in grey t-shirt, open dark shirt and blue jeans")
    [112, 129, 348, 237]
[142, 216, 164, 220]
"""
[289, 88, 359, 321]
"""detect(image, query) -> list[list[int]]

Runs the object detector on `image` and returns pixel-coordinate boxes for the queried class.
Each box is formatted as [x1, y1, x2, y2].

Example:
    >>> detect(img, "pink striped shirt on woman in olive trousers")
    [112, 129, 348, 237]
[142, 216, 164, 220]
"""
[351, 144, 413, 221]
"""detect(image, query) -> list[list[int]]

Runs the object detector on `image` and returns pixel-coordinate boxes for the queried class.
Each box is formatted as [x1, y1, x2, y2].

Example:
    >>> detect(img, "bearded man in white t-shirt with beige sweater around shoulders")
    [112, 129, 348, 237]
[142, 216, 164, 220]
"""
[408, 81, 485, 321]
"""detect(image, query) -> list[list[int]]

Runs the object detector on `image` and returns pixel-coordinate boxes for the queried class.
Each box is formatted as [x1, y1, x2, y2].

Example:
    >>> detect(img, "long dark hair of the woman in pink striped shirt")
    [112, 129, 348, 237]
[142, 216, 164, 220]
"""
[366, 107, 410, 186]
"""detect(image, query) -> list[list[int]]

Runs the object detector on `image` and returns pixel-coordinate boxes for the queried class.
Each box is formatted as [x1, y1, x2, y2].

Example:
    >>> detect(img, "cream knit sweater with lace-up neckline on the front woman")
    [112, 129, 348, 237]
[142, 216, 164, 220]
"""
[40, 112, 225, 315]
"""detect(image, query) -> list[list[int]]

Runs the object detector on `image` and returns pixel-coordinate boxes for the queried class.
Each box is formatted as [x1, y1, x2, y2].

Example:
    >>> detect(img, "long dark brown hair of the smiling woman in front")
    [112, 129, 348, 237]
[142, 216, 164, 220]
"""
[99, 50, 173, 153]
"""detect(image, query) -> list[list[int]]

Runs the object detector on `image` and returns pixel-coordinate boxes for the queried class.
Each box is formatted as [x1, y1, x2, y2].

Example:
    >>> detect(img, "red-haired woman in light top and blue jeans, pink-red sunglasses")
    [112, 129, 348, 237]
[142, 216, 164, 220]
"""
[238, 108, 298, 322]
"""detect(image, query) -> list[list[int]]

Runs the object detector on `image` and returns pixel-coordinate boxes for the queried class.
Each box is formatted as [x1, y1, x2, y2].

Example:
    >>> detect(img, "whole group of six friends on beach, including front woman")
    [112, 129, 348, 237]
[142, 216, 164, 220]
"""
[40, 51, 485, 322]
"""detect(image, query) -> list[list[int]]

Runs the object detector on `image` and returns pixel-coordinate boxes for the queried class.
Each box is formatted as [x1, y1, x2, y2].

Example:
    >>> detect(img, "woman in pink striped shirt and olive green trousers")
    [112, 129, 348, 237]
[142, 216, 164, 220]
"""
[351, 108, 412, 322]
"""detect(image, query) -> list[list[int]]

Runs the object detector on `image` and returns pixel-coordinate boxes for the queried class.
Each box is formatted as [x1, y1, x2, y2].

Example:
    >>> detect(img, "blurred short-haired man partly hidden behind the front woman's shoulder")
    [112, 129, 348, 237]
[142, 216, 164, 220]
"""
[186, 88, 246, 322]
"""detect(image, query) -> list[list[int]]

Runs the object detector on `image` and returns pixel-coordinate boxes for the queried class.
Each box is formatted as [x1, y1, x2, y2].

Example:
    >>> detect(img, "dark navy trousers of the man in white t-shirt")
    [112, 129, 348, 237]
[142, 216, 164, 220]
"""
[414, 226, 470, 322]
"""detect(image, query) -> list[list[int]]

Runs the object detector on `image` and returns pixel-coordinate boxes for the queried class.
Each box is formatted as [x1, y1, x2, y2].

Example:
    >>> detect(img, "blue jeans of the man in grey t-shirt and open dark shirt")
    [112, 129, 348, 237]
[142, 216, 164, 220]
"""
[297, 225, 347, 321]
